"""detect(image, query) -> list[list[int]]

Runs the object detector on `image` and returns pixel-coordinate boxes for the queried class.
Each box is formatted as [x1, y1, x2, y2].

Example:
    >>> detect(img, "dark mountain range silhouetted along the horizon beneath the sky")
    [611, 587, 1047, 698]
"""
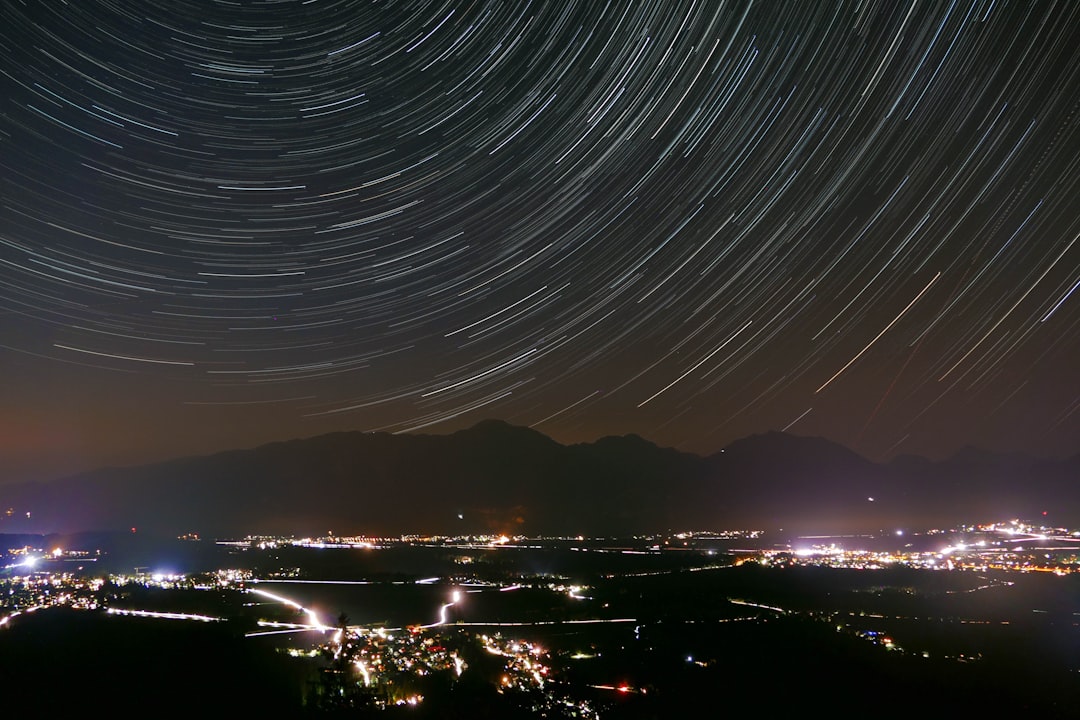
[0, 421, 1080, 535]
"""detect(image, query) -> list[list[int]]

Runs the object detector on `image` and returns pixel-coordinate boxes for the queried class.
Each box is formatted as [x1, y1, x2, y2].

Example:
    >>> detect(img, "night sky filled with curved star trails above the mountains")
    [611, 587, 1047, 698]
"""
[0, 0, 1080, 481]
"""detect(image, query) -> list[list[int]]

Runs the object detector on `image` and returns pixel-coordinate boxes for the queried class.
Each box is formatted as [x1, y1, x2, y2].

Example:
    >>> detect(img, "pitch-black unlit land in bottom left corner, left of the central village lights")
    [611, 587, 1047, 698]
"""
[0, 608, 306, 717]
